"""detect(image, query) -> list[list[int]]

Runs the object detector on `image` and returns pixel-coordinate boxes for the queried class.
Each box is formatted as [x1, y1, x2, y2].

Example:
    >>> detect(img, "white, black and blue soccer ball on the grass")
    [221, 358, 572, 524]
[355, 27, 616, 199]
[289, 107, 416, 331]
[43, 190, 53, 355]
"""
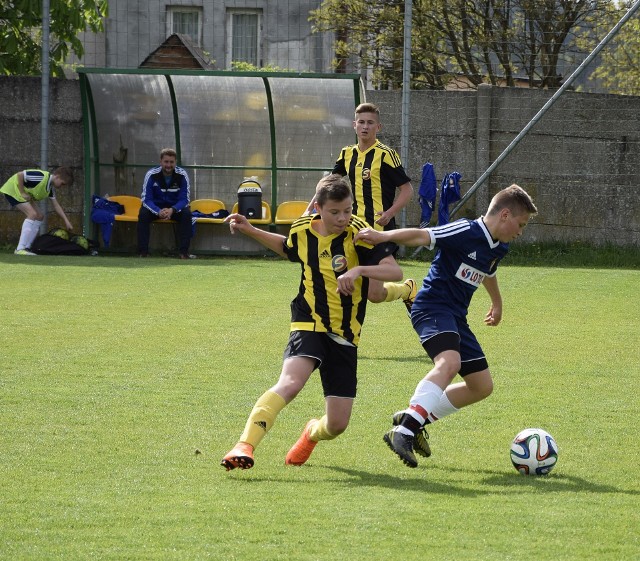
[511, 429, 558, 475]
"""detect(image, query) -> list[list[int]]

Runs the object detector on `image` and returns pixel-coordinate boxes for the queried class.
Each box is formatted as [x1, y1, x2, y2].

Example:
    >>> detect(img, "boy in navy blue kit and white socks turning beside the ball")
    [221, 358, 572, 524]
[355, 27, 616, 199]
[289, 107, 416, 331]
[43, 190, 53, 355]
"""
[356, 185, 538, 467]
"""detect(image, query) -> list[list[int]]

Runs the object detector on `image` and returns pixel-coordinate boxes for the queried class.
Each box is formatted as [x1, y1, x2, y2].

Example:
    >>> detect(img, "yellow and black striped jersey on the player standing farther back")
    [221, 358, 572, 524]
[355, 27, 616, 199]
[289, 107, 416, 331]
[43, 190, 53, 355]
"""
[333, 141, 411, 230]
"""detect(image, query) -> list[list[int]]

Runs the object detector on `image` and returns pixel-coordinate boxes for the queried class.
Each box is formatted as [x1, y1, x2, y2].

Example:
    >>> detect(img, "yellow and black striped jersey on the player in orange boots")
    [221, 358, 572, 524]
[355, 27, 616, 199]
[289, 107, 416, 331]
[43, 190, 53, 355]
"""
[284, 214, 397, 345]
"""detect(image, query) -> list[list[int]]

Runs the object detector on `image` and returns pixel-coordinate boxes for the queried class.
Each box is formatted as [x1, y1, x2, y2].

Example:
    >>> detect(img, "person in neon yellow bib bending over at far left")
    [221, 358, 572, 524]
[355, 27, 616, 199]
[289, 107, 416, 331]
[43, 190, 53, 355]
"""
[0, 167, 73, 255]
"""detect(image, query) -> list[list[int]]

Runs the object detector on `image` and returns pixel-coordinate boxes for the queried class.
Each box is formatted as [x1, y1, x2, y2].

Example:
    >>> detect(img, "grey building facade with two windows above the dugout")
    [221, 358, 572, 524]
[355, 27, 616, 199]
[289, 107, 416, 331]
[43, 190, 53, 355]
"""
[74, 0, 333, 73]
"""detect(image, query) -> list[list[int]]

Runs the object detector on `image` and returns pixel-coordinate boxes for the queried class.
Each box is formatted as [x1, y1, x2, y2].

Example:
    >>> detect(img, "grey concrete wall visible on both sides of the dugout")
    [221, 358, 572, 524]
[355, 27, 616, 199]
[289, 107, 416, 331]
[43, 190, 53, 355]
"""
[0, 77, 640, 247]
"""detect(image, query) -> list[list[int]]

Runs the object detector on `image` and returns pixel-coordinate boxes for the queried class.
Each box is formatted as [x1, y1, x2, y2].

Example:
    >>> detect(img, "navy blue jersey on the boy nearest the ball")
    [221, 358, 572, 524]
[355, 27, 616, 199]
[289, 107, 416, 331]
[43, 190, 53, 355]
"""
[411, 218, 509, 319]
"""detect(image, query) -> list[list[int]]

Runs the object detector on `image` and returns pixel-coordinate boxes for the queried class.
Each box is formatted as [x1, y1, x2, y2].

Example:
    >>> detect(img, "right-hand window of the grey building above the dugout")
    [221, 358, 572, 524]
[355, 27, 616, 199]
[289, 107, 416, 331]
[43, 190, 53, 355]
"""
[227, 10, 262, 67]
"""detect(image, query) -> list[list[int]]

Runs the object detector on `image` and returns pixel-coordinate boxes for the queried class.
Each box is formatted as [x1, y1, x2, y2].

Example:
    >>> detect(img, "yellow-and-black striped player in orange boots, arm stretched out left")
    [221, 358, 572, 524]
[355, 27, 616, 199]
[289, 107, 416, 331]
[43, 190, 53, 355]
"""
[220, 175, 402, 470]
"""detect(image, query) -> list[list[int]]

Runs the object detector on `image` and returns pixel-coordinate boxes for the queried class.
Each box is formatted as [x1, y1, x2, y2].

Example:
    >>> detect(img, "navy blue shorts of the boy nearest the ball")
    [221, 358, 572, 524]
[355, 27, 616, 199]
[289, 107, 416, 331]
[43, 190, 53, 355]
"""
[413, 310, 489, 376]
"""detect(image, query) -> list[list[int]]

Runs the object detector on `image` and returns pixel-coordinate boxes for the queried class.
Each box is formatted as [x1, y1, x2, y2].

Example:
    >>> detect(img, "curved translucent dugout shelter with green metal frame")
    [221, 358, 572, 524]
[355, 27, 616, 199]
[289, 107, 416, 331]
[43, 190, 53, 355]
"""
[78, 68, 364, 254]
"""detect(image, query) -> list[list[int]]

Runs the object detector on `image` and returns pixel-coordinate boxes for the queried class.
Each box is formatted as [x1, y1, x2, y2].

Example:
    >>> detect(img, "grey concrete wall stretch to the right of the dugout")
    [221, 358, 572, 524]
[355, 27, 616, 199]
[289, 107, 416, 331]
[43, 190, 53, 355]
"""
[367, 86, 640, 245]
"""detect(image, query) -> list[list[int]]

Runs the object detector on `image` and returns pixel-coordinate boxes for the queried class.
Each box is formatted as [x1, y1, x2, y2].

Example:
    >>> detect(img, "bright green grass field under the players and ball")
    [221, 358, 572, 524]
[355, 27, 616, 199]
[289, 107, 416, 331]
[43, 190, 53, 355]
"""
[0, 252, 640, 561]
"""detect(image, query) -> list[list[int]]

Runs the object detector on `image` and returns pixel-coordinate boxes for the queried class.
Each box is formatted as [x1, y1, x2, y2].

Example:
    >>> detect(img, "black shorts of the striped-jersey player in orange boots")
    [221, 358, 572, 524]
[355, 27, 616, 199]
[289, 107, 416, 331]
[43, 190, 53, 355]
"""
[284, 331, 358, 398]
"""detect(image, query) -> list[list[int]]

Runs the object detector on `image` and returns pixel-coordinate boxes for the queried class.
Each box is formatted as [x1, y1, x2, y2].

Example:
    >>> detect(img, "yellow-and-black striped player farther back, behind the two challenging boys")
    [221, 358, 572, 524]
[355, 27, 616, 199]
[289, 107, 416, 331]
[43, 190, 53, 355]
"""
[310, 103, 418, 311]
